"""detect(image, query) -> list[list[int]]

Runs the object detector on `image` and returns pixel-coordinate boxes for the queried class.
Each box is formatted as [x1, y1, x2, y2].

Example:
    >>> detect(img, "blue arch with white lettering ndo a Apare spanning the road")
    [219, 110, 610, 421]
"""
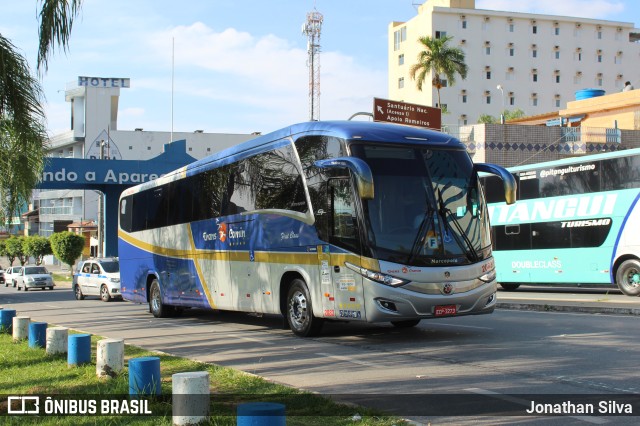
[37, 139, 196, 256]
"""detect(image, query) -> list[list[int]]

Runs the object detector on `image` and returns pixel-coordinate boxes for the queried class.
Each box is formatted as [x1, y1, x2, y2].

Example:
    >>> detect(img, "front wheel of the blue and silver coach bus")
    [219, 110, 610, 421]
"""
[287, 279, 323, 337]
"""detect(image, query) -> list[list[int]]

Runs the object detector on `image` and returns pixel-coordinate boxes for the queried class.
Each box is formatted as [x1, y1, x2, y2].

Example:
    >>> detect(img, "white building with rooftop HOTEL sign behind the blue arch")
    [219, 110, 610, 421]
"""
[33, 77, 255, 237]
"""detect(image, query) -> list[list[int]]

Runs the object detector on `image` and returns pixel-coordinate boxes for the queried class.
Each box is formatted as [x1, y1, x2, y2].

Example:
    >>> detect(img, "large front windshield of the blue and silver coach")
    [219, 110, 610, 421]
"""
[351, 144, 491, 266]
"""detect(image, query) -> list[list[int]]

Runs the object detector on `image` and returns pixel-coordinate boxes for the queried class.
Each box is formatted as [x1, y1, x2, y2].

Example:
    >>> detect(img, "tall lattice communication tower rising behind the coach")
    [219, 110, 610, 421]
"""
[302, 7, 324, 121]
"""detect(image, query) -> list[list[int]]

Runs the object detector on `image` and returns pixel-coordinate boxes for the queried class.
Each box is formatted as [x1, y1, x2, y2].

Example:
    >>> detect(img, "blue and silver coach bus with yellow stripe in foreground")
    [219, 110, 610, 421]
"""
[119, 121, 515, 336]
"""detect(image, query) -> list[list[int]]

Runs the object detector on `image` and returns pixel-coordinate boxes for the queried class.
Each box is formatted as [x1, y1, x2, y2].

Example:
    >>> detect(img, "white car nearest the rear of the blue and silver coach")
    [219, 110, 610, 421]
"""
[73, 258, 122, 302]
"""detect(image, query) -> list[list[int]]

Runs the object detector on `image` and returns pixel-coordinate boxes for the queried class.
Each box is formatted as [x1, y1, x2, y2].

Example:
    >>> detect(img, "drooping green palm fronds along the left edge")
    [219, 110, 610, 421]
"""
[0, 0, 82, 223]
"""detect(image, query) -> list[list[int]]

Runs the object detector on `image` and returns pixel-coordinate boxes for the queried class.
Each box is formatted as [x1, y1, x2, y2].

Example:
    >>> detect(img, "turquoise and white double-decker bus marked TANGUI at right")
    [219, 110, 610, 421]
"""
[484, 149, 640, 296]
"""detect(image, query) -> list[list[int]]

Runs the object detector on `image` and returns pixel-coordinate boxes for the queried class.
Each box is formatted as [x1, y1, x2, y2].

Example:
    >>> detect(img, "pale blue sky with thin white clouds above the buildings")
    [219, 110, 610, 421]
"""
[0, 0, 640, 135]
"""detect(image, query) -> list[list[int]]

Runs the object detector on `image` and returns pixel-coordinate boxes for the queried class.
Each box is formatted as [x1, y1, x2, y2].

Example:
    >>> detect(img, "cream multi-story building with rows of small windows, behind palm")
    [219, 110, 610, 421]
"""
[388, 0, 640, 125]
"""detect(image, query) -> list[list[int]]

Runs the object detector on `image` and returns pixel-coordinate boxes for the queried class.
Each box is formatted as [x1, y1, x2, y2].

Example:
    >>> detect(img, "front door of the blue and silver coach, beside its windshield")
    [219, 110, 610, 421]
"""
[318, 178, 366, 321]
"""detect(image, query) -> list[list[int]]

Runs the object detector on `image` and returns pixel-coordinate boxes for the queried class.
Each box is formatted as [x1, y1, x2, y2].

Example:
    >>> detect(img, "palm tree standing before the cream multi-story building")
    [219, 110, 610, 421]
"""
[409, 36, 468, 106]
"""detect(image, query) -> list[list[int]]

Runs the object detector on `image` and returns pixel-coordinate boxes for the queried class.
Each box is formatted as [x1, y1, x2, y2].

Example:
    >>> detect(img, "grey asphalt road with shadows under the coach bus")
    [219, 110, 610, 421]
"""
[0, 287, 640, 424]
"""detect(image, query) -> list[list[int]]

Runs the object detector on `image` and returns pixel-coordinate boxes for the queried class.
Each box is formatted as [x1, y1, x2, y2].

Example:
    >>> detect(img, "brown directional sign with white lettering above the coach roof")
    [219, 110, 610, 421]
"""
[373, 98, 442, 130]
